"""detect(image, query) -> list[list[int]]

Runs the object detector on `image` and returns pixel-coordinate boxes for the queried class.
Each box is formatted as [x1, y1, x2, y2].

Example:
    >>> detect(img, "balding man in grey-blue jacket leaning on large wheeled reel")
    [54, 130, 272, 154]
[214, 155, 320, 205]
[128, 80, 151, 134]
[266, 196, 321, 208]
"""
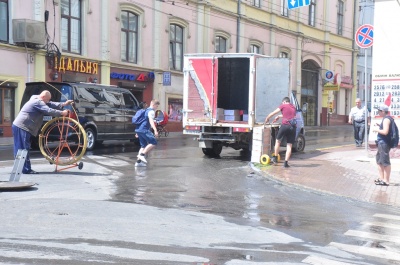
[12, 90, 73, 174]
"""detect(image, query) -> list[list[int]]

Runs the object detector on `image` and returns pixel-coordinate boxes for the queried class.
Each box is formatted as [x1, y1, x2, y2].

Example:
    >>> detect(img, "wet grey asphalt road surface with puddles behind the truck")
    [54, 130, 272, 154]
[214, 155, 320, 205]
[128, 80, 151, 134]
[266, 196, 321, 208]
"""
[0, 128, 400, 264]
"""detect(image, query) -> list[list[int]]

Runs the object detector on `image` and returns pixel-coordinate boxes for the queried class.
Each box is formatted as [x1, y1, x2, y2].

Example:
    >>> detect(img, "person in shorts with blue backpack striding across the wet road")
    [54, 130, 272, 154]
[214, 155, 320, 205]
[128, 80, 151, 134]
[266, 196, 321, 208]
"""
[135, 99, 160, 167]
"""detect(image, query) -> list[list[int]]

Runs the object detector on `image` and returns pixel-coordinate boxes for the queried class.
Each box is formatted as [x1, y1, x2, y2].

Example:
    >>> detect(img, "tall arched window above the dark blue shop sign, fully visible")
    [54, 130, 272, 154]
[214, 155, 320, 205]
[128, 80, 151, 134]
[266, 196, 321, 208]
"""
[121, 11, 138, 63]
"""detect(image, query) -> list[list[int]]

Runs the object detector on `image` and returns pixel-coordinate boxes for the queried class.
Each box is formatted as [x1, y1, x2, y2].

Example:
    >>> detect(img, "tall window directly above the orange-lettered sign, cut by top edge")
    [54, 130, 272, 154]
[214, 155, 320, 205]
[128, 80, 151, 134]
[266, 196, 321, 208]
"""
[61, 0, 81, 54]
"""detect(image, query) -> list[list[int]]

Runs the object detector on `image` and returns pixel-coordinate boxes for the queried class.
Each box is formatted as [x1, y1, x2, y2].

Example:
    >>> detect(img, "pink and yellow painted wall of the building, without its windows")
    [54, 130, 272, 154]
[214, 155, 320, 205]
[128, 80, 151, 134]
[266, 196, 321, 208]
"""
[0, 0, 357, 130]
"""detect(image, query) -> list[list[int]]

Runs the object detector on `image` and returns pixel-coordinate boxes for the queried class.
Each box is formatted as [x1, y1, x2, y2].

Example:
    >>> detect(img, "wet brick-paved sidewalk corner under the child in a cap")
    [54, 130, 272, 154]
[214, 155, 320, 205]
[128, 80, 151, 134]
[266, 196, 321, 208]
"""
[0, 132, 400, 207]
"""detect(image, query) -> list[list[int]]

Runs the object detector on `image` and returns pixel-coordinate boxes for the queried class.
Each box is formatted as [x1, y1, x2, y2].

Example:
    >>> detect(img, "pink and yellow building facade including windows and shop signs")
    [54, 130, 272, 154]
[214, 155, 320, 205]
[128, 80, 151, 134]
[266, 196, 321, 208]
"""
[0, 0, 358, 136]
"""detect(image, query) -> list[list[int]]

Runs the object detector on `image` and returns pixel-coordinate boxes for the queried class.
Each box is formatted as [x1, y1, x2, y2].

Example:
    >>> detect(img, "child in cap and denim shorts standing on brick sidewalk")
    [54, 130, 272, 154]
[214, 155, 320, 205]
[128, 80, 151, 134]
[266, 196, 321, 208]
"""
[373, 104, 392, 186]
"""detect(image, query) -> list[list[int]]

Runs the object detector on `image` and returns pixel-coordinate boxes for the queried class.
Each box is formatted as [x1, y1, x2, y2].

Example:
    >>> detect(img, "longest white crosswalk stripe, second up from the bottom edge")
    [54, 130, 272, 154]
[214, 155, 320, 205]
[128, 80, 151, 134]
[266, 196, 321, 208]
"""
[329, 242, 400, 261]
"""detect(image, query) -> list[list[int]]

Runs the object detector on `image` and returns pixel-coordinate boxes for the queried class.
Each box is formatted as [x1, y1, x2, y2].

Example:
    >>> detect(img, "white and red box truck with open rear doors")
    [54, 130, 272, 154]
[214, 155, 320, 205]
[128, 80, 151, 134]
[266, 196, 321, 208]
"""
[182, 53, 305, 162]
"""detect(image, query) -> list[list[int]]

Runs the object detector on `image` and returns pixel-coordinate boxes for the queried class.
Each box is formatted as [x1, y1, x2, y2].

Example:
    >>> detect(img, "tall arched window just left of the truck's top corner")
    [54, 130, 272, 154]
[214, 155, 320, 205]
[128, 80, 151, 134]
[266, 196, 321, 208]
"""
[169, 24, 183, 70]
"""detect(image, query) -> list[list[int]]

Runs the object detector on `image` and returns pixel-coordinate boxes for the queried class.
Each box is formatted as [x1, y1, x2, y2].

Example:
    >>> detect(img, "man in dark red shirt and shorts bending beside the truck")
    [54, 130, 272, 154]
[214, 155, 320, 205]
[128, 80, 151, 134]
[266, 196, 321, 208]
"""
[265, 97, 296, 167]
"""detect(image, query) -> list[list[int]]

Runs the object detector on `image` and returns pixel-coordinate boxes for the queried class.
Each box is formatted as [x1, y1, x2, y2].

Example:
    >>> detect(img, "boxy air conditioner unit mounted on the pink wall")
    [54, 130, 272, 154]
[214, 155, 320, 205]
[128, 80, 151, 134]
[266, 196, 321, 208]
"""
[13, 19, 45, 45]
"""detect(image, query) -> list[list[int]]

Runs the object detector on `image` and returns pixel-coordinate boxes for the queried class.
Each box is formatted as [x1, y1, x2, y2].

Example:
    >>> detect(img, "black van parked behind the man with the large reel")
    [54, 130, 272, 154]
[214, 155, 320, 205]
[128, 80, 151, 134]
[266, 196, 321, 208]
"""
[21, 82, 139, 150]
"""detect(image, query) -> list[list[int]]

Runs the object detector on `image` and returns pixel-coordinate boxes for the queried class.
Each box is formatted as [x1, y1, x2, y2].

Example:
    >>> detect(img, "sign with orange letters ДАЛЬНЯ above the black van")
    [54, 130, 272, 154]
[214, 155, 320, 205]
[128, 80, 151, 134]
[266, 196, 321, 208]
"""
[55, 57, 99, 75]
